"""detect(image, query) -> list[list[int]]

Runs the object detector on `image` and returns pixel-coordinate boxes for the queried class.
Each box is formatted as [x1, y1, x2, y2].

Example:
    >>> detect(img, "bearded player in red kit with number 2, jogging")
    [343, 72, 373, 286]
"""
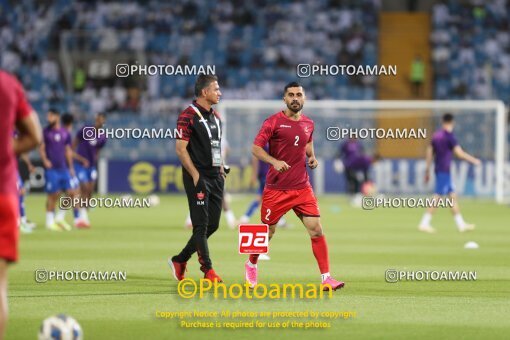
[245, 82, 344, 290]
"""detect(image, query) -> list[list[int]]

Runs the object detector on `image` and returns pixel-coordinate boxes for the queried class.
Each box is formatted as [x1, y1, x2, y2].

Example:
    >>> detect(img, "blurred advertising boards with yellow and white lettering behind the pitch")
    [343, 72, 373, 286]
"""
[99, 158, 510, 196]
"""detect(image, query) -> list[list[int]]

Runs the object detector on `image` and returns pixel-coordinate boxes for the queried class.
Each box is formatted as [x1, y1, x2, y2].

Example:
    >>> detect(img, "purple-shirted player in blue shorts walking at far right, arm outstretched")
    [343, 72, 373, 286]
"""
[418, 113, 480, 233]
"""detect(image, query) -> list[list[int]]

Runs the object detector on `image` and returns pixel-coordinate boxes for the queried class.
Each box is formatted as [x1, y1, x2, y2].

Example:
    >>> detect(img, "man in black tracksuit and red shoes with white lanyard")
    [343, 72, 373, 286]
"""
[168, 75, 225, 282]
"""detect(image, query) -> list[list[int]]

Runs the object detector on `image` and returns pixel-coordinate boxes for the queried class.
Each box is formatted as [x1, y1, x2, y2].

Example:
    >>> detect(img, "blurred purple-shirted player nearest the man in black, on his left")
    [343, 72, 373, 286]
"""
[73, 113, 106, 227]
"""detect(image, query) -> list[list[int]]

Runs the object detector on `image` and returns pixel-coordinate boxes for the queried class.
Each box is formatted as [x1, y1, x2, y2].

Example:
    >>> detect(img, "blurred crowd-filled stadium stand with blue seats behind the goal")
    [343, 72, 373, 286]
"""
[0, 0, 510, 159]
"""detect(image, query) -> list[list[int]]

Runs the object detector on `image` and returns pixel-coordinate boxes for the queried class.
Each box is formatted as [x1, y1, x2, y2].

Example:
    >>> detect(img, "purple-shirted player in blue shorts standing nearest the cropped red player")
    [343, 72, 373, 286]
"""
[39, 109, 76, 231]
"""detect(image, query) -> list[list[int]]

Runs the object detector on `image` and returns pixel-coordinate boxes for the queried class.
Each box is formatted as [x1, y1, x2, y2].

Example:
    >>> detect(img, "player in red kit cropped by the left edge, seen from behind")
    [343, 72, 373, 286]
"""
[0, 70, 42, 340]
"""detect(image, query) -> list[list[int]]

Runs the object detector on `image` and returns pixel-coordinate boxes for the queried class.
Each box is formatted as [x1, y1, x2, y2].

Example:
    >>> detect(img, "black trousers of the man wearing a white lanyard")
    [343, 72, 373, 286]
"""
[175, 169, 225, 273]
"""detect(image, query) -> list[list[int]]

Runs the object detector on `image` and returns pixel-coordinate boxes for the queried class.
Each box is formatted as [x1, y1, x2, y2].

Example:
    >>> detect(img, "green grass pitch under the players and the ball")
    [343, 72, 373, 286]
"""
[7, 195, 510, 340]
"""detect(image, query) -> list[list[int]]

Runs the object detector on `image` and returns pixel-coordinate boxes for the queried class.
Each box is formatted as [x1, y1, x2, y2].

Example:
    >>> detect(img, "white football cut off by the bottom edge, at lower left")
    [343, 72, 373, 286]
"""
[39, 314, 83, 340]
